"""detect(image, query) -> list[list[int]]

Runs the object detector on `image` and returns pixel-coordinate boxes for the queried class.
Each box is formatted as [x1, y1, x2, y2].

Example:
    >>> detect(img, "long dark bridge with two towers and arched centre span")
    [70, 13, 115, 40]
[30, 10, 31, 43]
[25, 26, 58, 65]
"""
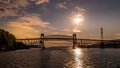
[16, 33, 107, 49]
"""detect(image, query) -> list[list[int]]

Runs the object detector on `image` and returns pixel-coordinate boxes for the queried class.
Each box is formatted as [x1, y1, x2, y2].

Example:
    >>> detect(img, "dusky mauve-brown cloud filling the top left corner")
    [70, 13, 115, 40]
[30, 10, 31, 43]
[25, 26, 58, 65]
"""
[0, 0, 29, 17]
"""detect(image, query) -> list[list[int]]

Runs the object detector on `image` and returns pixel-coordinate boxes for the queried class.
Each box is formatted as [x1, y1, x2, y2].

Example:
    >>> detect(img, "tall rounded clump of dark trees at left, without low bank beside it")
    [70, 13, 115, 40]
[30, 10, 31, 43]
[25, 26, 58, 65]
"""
[0, 29, 16, 50]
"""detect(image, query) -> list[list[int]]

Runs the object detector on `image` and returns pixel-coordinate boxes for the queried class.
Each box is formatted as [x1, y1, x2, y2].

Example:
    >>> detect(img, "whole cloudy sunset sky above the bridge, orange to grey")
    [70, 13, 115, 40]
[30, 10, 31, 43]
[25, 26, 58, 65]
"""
[0, 0, 120, 39]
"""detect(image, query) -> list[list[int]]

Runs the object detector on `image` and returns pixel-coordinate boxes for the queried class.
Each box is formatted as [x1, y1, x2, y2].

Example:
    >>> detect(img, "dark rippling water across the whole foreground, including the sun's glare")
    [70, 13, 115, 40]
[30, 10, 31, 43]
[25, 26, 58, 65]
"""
[0, 43, 120, 68]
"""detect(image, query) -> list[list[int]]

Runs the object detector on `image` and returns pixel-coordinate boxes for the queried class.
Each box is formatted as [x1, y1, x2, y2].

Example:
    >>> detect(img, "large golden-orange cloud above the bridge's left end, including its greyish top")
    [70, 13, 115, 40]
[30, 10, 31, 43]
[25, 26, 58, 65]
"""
[6, 14, 49, 38]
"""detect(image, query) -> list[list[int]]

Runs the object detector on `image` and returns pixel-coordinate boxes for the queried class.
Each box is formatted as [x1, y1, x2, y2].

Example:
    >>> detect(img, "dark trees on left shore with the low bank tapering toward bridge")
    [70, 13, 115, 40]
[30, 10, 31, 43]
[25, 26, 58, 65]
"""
[0, 29, 28, 50]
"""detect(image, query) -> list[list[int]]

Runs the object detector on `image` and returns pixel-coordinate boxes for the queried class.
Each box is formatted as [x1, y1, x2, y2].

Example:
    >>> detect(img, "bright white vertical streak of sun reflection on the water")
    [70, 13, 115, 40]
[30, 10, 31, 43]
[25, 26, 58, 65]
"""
[74, 48, 82, 68]
